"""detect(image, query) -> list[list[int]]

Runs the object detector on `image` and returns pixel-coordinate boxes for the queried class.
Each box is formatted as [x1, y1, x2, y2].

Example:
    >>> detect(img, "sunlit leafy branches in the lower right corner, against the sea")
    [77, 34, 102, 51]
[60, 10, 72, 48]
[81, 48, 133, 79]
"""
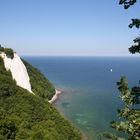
[104, 77, 140, 140]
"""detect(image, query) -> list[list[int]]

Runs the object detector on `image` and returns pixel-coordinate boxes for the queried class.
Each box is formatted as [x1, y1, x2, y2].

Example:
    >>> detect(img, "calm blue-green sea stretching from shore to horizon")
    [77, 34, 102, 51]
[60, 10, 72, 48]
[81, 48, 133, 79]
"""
[23, 56, 140, 140]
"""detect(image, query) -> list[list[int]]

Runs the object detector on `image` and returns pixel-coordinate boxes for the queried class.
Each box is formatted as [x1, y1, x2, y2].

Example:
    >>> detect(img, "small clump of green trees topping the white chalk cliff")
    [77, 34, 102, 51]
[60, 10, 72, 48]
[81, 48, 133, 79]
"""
[0, 45, 14, 59]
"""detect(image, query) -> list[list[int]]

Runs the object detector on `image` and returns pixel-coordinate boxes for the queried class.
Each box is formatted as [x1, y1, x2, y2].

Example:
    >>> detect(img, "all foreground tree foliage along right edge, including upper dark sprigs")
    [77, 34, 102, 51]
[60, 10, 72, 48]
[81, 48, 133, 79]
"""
[103, 0, 140, 140]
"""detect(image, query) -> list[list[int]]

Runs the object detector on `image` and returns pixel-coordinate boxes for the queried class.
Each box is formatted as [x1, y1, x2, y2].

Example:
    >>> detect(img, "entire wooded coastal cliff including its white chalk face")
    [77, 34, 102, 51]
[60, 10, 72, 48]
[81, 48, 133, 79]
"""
[0, 48, 82, 140]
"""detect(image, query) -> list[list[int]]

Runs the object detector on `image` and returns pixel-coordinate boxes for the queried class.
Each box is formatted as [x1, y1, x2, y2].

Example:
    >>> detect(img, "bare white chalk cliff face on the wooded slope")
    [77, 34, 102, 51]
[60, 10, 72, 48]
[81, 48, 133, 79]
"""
[0, 53, 33, 93]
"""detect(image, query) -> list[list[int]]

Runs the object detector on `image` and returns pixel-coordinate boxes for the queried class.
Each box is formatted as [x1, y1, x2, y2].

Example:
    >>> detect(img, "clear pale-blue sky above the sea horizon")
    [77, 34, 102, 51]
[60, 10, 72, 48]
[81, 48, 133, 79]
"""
[0, 0, 140, 56]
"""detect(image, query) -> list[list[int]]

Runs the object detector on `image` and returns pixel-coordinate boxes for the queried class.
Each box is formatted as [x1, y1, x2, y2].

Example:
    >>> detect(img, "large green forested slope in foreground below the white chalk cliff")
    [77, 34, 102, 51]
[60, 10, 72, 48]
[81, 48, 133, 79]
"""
[0, 58, 81, 140]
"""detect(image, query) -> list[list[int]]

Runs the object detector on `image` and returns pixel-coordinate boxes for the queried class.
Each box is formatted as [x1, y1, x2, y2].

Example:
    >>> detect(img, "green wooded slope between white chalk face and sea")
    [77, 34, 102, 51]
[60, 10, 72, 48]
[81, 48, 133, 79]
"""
[22, 60, 55, 100]
